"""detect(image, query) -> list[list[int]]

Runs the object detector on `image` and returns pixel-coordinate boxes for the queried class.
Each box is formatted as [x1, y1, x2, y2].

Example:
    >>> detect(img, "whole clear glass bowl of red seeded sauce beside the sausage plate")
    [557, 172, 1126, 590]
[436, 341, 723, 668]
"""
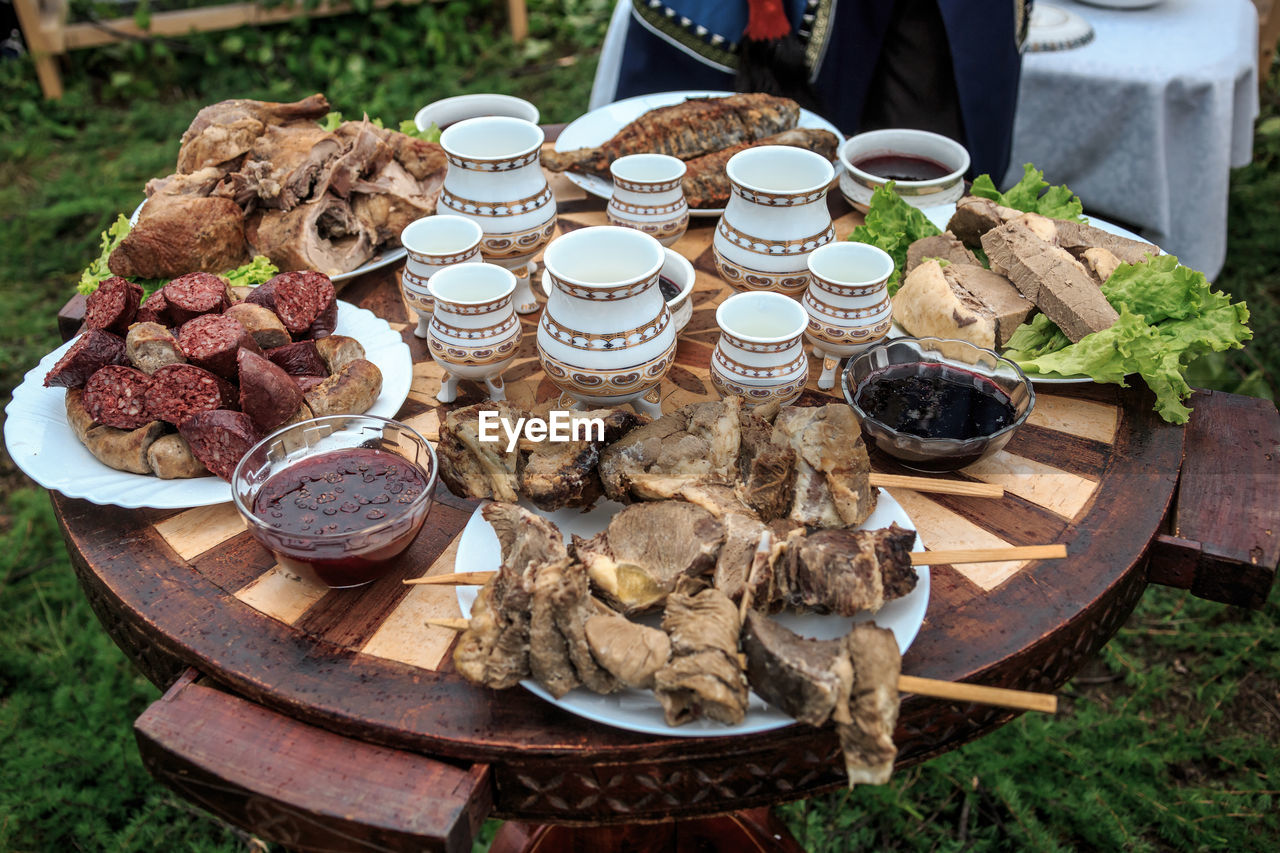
[232, 415, 438, 589]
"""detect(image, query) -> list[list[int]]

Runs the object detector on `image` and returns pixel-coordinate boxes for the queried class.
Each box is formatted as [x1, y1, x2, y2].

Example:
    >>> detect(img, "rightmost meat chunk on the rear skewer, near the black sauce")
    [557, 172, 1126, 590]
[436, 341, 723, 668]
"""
[773, 403, 877, 528]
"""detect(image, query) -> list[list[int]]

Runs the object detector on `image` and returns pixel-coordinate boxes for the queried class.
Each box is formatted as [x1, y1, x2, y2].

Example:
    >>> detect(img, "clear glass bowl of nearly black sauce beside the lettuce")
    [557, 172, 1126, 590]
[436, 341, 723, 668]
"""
[841, 338, 1036, 471]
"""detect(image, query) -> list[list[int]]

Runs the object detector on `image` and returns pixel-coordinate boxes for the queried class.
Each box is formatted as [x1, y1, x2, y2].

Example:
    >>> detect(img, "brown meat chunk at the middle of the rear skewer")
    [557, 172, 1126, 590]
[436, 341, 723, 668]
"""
[600, 397, 742, 503]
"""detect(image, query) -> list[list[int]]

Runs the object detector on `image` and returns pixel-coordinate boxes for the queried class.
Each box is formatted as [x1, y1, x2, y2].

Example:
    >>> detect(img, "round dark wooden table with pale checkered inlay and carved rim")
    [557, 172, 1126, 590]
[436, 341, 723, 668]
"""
[54, 175, 1280, 849]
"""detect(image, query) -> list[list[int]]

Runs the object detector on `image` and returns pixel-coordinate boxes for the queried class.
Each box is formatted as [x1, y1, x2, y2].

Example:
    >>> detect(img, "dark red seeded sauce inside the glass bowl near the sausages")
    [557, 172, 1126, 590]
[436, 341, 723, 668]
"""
[253, 447, 430, 588]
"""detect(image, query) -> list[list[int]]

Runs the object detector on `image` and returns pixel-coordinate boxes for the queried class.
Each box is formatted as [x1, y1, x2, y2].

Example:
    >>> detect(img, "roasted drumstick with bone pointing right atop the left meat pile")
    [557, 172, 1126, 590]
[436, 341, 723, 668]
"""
[178, 95, 329, 174]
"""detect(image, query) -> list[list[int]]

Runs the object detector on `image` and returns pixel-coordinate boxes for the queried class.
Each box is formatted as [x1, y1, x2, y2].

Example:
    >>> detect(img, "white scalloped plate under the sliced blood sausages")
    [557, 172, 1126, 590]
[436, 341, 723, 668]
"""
[4, 300, 413, 510]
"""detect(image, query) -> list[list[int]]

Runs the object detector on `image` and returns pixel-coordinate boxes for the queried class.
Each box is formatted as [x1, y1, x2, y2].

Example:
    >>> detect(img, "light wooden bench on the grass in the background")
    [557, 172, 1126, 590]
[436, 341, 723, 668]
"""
[14, 0, 529, 99]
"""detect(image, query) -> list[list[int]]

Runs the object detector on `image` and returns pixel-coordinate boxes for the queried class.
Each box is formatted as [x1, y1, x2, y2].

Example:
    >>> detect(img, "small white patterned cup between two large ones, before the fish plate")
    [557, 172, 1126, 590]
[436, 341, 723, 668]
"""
[604, 154, 689, 246]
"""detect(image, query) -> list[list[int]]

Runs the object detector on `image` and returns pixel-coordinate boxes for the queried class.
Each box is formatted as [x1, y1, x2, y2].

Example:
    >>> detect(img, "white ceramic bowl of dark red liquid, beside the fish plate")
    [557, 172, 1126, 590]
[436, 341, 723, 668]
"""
[840, 128, 969, 213]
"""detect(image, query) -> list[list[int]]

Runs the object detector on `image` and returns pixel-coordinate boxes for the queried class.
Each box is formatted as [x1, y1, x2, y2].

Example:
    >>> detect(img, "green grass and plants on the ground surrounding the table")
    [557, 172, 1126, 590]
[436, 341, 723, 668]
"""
[0, 0, 1280, 853]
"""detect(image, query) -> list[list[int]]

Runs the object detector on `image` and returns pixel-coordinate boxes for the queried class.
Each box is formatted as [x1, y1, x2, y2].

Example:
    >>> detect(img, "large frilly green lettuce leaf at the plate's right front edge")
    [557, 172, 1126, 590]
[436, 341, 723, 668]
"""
[1005, 255, 1253, 424]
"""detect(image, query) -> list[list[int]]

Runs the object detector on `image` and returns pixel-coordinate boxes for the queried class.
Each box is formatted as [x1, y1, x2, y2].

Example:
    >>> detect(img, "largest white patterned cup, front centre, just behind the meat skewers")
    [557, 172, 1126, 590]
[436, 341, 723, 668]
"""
[538, 225, 676, 418]
